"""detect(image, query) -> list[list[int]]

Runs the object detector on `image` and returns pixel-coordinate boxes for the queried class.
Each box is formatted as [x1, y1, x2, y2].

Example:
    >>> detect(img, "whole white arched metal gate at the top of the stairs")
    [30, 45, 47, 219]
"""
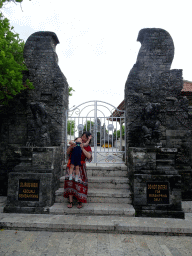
[65, 100, 126, 164]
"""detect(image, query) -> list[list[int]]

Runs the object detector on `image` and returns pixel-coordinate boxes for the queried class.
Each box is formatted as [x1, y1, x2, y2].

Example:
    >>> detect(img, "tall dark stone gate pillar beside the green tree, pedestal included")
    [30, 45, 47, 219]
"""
[4, 32, 68, 213]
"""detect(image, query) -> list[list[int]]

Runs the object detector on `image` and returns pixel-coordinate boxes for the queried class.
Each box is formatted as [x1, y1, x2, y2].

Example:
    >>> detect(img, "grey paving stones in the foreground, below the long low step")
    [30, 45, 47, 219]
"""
[0, 230, 192, 256]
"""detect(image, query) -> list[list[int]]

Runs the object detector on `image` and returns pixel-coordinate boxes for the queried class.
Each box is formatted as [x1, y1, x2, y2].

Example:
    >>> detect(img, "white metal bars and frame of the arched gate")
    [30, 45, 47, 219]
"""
[65, 100, 126, 164]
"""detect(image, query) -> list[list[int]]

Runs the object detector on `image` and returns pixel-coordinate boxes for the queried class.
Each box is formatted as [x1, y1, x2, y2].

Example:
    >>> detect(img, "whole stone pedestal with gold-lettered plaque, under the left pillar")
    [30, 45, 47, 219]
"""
[4, 147, 63, 213]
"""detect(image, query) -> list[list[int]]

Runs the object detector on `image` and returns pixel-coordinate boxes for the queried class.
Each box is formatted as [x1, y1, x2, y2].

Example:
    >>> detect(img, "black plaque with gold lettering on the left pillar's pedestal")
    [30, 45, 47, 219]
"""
[18, 179, 39, 201]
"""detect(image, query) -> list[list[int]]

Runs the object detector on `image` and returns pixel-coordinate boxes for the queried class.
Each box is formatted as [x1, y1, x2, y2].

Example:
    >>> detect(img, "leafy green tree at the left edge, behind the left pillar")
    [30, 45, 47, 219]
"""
[0, 0, 34, 105]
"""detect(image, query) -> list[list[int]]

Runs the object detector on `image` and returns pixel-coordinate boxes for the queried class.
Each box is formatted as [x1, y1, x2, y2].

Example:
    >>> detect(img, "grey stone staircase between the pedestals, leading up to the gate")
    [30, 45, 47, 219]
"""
[49, 164, 135, 217]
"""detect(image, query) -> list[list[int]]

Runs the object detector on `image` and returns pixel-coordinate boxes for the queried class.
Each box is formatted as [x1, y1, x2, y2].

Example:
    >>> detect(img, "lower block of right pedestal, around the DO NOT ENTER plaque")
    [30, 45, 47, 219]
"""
[134, 174, 185, 219]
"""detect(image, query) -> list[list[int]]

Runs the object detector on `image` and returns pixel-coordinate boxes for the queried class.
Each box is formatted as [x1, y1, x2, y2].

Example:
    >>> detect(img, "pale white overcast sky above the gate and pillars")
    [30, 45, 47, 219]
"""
[3, 0, 192, 115]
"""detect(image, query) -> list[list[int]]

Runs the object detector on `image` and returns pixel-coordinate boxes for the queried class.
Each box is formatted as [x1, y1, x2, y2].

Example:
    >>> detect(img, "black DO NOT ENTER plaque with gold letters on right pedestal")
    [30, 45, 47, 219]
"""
[147, 181, 169, 204]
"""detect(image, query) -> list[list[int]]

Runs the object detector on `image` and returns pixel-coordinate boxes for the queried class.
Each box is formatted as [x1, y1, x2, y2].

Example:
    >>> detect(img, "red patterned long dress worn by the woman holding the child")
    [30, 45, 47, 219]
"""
[63, 146, 92, 203]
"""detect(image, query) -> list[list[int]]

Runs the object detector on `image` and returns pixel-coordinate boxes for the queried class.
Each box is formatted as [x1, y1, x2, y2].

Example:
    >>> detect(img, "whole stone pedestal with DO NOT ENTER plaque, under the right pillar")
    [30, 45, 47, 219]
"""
[129, 148, 184, 218]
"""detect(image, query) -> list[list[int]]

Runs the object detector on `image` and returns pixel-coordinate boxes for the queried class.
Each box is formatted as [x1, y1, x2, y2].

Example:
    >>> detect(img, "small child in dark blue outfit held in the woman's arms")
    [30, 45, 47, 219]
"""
[69, 135, 92, 182]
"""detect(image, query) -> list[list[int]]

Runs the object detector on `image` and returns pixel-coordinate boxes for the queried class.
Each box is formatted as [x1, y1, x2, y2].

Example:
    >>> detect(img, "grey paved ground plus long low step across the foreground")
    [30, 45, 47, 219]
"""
[0, 197, 192, 256]
